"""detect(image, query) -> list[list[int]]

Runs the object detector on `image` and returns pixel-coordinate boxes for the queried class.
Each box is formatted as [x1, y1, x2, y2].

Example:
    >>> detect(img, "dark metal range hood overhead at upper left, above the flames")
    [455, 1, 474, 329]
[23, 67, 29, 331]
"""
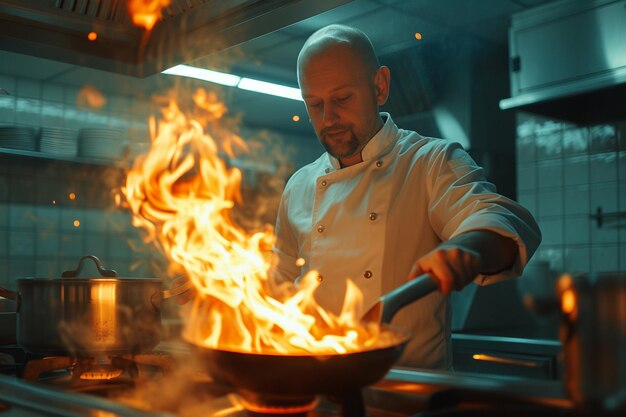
[0, 0, 350, 77]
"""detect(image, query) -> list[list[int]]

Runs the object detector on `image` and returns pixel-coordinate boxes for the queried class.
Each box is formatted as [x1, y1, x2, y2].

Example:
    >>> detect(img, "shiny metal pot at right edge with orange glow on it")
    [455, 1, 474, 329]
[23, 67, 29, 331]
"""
[557, 273, 626, 411]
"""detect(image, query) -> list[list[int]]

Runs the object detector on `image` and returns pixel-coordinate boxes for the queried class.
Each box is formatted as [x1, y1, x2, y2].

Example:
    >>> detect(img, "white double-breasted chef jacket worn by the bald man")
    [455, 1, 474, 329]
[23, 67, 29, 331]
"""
[274, 113, 541, 369]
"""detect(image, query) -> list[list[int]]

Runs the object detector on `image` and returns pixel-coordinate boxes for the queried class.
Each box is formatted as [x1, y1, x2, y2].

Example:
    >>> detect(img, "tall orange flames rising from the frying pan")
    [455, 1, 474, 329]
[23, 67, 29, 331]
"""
[122, 92, 382, 354]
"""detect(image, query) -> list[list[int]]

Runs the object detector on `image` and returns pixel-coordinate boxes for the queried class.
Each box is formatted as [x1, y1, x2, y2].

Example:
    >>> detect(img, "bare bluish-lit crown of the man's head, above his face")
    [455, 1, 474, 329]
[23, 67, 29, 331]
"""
[298, 25, 380, 85]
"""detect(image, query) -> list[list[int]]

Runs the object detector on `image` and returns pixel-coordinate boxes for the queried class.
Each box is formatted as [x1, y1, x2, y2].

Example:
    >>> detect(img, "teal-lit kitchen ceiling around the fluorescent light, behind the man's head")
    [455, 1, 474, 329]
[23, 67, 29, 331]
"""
[0, 0, 553, 135]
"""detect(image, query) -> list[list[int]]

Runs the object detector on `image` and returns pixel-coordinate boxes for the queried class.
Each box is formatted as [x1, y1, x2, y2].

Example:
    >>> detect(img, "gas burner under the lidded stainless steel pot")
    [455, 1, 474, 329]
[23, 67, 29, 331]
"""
[22, 353, 175, 391]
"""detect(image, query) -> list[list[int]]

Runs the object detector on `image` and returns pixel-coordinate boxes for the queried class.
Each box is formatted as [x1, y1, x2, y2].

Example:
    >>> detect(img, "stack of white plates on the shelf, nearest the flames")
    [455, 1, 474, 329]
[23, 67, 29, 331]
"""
[78, 128, 126, 159]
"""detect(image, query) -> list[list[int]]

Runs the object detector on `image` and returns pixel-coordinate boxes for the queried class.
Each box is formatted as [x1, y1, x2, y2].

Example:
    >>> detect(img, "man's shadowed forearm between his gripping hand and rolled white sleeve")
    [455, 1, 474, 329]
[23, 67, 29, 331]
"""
[446, 230, 518, 275]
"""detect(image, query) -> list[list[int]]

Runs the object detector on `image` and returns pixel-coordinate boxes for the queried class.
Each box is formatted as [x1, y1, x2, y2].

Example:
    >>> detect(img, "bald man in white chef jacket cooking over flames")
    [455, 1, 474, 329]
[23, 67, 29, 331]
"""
[273, 25, 541, 369]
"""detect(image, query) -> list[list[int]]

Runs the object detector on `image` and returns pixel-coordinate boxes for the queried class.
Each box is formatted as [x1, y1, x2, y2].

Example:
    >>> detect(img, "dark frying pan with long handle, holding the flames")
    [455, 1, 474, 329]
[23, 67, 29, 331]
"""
[188, 275, 438, 397]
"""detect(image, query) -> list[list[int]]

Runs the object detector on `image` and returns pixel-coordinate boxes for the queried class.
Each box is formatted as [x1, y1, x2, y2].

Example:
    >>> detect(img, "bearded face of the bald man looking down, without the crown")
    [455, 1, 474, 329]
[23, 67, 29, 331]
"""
[299, 45, 380, 160]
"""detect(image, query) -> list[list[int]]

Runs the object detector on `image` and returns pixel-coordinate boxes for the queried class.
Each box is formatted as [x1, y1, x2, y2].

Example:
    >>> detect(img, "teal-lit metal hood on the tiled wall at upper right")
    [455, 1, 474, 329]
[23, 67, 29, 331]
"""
[500, 0, 626, 124]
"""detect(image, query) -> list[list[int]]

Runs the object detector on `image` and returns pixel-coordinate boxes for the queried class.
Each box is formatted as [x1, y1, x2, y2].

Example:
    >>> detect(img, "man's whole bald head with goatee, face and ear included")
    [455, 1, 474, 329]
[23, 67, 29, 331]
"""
[298, 25, 390, 167]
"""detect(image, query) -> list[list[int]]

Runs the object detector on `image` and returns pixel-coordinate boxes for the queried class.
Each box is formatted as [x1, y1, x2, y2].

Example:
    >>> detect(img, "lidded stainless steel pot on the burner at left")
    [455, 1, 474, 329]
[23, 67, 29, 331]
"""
[0, 255, 190, 356]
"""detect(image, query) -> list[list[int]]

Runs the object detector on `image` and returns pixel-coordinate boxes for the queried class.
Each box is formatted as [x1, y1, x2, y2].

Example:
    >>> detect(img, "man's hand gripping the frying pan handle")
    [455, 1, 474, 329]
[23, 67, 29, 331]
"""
[409, 242, 482, 295]
